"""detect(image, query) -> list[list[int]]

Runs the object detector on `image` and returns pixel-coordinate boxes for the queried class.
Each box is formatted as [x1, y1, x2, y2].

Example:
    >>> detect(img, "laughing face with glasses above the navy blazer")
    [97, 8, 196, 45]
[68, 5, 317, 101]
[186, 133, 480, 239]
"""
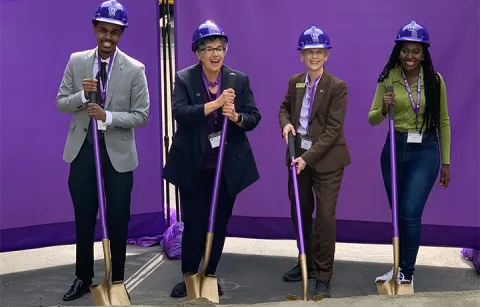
[196, 38, 227, 73]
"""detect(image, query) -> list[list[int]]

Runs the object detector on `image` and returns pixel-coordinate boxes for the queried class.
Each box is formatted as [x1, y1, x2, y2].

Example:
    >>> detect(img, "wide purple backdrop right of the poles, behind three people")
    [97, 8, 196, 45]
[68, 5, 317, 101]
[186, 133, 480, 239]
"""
[175, 0, 480, 248]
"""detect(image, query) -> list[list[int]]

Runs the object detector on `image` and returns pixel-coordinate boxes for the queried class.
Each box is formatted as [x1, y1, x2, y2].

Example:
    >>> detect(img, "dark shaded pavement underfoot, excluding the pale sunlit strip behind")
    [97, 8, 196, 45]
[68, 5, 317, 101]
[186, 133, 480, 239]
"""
[0, 246, 480, 306]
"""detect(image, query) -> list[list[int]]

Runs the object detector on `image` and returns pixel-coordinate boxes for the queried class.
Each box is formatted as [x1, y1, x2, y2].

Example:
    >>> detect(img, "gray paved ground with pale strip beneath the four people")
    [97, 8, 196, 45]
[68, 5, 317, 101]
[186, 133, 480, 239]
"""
[0, 238, 480, 307]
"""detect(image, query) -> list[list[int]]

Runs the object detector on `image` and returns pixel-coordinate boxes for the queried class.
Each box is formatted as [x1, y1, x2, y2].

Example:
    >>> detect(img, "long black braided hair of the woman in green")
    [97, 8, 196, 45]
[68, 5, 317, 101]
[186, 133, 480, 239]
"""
[377, 42, 440, 132]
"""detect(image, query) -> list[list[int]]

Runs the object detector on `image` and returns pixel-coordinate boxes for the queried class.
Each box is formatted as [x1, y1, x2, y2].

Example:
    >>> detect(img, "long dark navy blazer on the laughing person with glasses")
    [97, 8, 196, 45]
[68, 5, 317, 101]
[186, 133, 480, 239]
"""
[163, 64, 262, 197]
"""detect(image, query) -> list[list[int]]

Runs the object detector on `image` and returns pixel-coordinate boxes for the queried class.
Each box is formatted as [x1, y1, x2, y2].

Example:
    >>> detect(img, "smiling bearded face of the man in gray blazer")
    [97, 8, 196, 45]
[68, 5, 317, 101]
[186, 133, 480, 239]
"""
[93, 21, 123, 58]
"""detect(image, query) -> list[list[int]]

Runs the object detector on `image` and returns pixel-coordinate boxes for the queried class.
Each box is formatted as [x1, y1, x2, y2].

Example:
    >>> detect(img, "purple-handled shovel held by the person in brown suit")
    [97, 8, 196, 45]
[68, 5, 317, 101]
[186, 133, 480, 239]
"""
[287, 131, 308, 301]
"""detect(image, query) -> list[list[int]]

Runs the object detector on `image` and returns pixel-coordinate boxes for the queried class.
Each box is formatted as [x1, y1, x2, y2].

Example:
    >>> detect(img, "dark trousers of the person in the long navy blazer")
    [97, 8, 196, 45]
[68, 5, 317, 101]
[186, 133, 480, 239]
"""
[180, 169, 235, 275]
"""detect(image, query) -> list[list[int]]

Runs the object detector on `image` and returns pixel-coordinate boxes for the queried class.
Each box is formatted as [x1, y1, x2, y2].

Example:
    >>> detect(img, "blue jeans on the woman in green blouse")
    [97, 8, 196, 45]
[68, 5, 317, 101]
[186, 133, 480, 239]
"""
[381, 131, 440, 279]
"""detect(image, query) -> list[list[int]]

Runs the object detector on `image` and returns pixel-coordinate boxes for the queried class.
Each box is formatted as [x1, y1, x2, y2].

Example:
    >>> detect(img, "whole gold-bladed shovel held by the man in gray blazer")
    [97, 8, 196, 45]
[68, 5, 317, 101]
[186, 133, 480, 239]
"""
[89, 93, 130, 306]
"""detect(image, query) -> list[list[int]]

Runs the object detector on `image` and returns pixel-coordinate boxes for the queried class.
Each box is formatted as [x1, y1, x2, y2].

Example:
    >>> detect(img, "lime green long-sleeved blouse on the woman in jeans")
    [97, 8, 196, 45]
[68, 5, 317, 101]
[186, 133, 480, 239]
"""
[368, 67, 450, 164]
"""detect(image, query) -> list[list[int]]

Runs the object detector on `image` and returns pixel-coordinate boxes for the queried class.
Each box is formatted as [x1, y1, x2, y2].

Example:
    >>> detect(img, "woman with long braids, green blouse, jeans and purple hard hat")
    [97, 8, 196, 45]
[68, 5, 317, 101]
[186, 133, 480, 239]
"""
[368, 21, 450, 290]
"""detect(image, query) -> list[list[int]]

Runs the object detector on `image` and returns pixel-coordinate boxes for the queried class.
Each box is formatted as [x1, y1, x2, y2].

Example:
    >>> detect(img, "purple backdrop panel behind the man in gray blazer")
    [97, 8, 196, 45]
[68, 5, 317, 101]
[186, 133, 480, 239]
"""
[0, 0, 165, 251]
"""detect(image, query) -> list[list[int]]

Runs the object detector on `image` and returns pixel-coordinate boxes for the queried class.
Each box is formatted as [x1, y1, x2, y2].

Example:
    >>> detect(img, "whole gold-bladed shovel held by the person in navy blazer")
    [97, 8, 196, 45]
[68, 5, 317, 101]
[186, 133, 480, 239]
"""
[184, 72, 236, 304]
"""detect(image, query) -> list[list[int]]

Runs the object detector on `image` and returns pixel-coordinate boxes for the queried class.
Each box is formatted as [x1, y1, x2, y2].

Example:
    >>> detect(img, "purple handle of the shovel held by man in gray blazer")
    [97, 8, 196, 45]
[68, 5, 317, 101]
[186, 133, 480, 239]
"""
[89, 93, 108, 239]
